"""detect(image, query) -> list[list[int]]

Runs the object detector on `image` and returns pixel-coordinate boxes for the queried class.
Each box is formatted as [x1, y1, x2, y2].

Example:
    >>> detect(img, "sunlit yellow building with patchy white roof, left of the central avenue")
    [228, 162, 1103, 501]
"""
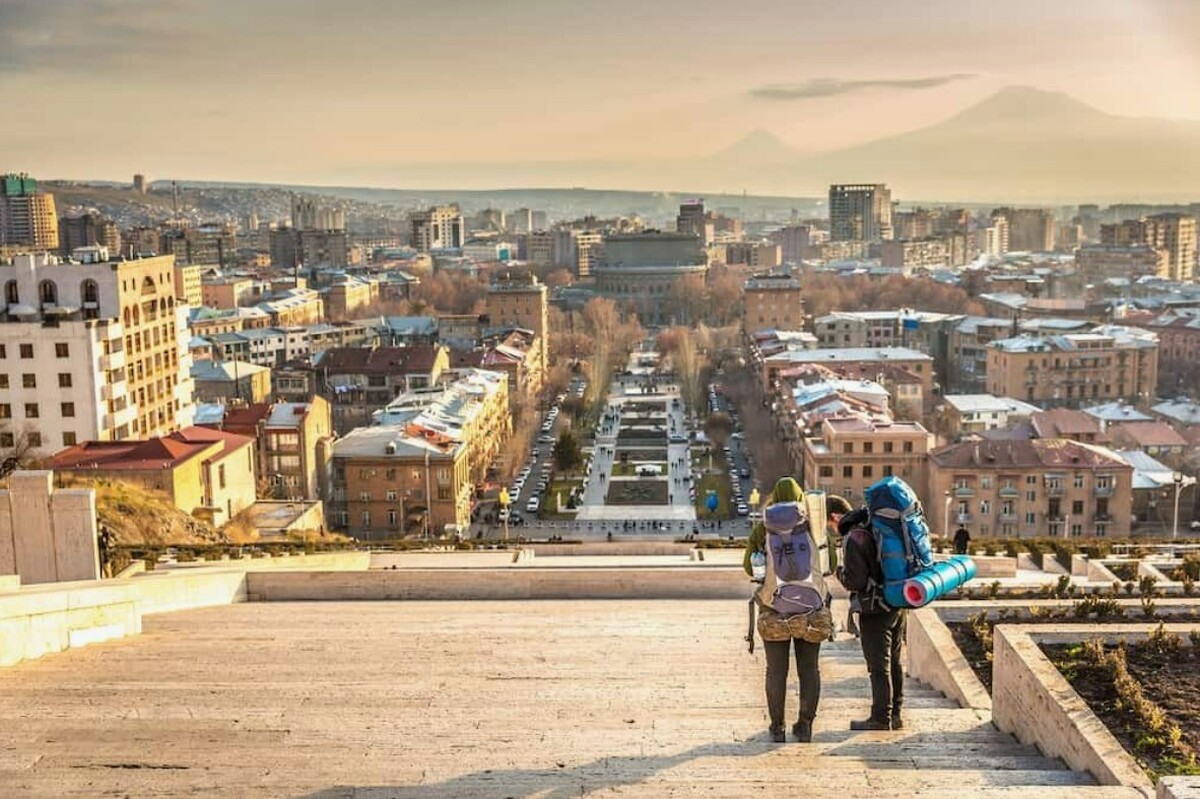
[373, 368, 512, 483]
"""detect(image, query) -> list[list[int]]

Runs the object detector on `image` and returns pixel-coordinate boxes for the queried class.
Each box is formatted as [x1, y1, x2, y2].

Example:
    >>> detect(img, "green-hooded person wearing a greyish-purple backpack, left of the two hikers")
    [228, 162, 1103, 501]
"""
[742, 477, 833, 743]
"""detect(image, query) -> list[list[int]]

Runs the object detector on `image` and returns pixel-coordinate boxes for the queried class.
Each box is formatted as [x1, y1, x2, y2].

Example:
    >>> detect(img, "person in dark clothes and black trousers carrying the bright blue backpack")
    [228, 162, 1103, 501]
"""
[838, 507, 908, 729]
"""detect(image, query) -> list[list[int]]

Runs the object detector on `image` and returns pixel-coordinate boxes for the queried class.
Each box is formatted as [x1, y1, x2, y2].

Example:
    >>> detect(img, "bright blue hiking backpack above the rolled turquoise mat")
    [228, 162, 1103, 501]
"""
[866, 477, 934, 608]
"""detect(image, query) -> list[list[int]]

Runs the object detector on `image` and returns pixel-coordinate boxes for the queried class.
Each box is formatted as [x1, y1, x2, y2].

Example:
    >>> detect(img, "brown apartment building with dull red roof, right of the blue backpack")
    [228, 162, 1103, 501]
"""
[925, 438, 1133, 539]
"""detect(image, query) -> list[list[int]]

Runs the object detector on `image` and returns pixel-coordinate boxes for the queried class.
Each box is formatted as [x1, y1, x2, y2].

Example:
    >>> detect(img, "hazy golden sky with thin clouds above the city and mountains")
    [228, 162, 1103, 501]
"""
[0, 0, 1200, 184]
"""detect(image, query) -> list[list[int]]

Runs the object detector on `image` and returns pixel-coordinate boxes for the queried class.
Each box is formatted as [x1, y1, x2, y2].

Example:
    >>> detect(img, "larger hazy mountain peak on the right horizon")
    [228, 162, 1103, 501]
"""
[793, 86, 1200, 203]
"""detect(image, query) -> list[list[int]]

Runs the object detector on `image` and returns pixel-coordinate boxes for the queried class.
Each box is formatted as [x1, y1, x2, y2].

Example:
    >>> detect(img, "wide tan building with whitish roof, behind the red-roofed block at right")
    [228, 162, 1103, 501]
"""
[986, 325, 1158, 408]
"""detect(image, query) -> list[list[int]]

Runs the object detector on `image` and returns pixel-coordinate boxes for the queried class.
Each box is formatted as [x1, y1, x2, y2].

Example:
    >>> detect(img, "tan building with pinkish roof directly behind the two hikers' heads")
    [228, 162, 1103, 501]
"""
[800, 417, 934, 503]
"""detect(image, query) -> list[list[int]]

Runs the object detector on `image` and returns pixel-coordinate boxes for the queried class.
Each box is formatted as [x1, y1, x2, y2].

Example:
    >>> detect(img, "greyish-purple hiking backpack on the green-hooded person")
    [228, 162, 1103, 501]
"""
[758, 501, 828, 615]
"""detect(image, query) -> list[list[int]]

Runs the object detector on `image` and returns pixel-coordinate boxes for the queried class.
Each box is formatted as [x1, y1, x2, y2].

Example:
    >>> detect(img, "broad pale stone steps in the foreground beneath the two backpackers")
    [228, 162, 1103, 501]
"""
[0, 600, 1139, 799]
